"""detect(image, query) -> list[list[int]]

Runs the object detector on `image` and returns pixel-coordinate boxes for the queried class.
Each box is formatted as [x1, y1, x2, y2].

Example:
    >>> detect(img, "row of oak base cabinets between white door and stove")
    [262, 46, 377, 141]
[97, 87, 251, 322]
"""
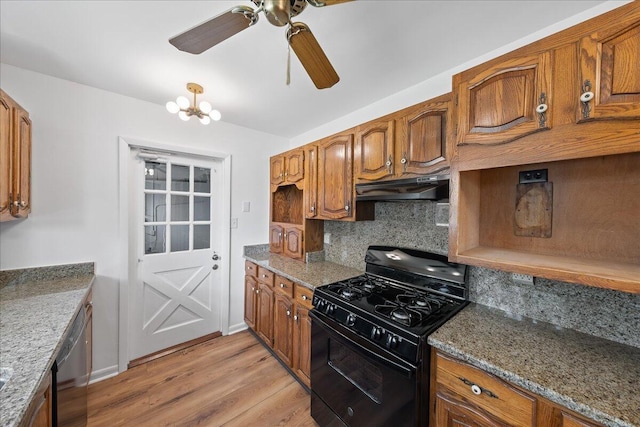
[244, 261, 313, 387]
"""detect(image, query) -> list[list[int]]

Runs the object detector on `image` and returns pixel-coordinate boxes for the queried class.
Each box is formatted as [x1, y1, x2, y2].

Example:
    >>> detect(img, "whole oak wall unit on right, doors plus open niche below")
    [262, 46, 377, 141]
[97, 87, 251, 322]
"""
[449, 2, 640, 293]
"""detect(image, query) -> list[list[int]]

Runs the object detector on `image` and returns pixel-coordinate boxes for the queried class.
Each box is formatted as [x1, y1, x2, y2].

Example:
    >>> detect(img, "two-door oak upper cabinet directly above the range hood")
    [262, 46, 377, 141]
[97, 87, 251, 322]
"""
[354, 94, 453, 183]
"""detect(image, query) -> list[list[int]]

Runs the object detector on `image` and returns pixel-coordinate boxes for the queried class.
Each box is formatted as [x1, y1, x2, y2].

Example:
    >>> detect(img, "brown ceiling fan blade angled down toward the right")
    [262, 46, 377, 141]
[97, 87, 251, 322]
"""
[287, 22, 340, 89]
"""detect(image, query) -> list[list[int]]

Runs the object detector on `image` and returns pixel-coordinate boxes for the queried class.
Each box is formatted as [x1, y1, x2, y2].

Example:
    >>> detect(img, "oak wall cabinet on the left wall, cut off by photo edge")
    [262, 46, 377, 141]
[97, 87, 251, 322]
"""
[0, 90, 31, 221]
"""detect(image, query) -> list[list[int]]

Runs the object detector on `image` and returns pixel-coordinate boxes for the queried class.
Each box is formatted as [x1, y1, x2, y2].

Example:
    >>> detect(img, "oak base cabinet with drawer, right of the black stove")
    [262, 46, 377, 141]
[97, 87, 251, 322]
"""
[431, 350, 602, 427]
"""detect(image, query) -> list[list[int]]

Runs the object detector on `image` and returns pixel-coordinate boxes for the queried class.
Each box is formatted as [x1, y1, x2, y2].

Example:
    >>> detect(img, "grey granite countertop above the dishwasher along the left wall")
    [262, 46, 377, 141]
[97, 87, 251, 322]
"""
[0, 263, 94, 427]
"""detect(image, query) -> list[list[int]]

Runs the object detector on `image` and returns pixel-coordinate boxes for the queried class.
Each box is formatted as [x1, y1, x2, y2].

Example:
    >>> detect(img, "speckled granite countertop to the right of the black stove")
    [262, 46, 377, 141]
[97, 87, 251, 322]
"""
[429, 304, 640, 426]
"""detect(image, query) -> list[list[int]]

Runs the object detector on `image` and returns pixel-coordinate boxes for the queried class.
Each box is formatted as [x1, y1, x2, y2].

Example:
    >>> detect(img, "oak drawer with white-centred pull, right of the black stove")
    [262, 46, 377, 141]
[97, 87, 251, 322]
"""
[436, 353, 536, 426]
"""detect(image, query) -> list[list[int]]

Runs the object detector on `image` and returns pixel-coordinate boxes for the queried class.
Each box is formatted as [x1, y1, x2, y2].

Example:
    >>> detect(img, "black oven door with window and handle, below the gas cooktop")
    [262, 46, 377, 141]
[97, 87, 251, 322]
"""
[310, 310, 419, 427]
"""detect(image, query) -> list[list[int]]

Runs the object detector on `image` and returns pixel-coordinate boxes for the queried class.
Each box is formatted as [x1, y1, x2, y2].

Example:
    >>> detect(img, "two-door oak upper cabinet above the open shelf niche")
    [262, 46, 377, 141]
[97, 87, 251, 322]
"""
[453, 2, 640, 171]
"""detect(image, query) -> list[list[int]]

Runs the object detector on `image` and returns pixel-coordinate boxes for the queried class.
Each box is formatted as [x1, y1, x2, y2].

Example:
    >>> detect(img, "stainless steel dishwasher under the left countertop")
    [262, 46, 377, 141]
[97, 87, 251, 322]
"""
[53, 307, 89, 427]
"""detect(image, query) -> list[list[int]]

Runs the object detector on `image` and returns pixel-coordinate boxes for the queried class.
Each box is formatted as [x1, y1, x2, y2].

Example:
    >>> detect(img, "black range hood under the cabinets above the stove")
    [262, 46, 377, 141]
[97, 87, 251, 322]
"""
[356, 173, 450, 201]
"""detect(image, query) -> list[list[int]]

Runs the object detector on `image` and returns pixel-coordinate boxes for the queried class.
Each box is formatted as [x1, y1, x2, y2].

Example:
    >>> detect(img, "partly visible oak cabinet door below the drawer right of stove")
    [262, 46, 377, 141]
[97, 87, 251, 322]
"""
[435, 393, 510, 427]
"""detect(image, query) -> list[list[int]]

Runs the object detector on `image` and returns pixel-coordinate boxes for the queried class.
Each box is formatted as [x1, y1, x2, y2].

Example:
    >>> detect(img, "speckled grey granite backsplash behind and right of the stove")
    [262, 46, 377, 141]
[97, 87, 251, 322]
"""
[324, 201, 640, 347]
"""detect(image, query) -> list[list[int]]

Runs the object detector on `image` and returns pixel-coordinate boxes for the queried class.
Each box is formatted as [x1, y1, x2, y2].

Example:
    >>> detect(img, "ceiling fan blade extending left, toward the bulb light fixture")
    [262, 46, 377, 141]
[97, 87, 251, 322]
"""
[169, 6, 258, 54]
